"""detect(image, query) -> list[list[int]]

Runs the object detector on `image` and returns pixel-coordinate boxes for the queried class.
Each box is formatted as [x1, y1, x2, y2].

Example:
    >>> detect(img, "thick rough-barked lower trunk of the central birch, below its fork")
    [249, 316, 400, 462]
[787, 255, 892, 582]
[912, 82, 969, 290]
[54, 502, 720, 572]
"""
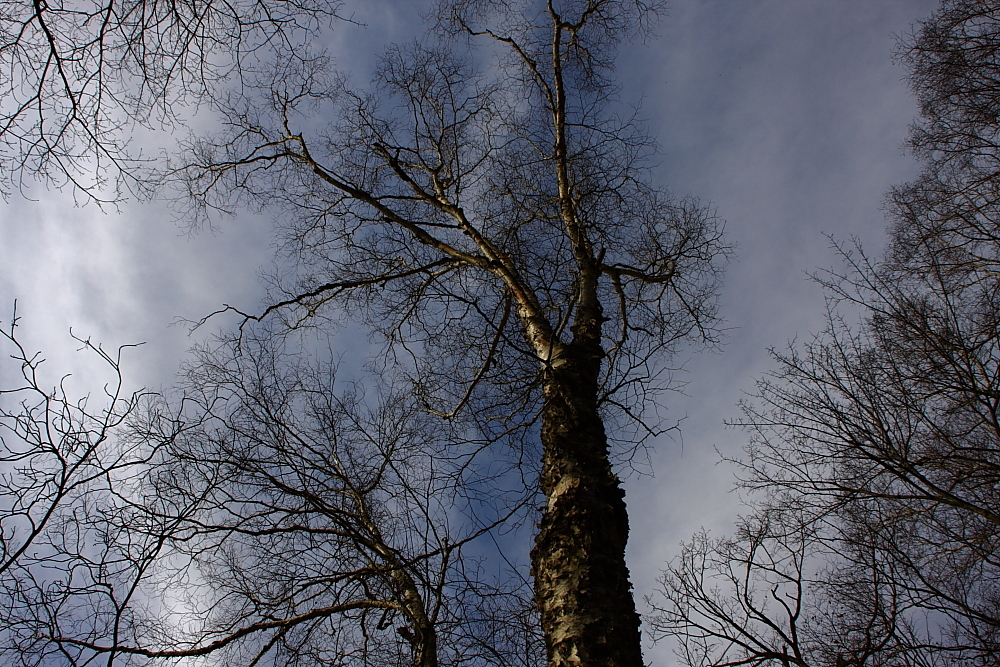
[531, 344, 643, 667]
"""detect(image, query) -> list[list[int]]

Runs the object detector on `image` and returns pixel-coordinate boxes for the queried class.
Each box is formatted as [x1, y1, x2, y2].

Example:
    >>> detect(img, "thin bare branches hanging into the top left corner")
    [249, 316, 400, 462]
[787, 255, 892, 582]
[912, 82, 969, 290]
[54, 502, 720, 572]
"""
[0, 0, 340, 198]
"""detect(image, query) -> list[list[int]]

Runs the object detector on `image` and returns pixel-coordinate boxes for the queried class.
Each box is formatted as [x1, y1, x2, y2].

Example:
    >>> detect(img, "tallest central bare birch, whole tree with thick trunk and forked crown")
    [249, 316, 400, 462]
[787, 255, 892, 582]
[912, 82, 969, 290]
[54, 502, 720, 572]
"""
[173, 0, 728, 666]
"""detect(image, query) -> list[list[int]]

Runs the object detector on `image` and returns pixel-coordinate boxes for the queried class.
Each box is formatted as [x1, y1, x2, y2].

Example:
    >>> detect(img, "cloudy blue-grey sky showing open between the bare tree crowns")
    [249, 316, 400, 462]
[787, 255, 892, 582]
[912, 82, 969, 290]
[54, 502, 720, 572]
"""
[0, 0, 936, 665]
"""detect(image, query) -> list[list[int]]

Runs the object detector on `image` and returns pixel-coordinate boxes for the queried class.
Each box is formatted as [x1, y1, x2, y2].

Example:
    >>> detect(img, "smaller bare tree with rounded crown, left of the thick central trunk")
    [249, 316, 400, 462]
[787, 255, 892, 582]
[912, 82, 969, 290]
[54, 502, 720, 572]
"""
[140, 332, 532, 667]
